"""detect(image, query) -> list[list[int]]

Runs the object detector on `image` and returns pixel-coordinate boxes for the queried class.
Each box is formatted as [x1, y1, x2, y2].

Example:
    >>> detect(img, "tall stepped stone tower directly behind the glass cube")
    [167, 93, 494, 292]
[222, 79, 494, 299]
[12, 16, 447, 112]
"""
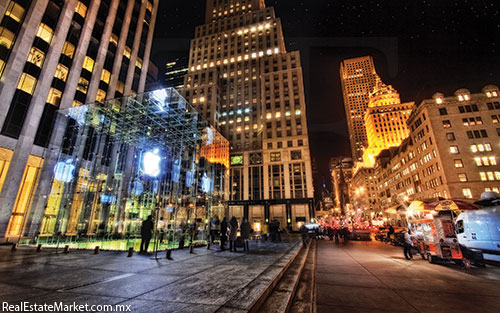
[183, 0, 313, 229]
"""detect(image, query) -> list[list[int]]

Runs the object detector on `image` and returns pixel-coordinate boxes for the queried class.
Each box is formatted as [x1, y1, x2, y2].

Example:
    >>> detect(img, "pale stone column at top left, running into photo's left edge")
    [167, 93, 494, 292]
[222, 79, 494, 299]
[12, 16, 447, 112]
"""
[0, 0, 48, 124]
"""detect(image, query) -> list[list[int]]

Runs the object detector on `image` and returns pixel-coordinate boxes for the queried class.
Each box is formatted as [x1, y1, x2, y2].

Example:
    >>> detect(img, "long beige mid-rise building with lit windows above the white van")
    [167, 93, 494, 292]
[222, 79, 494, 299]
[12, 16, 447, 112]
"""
[375, 85, 500, 209]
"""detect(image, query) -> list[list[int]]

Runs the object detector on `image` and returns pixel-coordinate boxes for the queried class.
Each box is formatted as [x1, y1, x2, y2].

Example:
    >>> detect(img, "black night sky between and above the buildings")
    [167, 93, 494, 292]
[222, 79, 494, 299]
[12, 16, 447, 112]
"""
[153, 0, 500, 195]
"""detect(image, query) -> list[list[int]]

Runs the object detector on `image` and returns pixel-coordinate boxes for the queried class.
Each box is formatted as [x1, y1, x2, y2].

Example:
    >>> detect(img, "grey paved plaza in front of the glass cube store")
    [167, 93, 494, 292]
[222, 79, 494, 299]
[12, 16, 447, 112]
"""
[0, 238, 301, 312]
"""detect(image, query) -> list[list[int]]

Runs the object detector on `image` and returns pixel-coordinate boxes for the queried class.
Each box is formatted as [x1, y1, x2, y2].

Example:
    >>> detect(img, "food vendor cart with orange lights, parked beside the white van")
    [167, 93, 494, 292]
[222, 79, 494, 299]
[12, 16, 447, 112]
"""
[409, 210, 470, 268]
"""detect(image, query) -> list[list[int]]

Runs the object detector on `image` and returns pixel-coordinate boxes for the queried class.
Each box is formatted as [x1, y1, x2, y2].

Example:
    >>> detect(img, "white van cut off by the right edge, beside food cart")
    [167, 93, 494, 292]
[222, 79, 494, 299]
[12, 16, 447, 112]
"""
[456, 205, 500, 262]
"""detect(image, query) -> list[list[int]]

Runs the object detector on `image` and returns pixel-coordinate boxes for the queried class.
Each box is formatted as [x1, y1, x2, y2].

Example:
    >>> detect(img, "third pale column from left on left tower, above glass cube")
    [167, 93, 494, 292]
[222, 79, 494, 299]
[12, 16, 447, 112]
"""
[60, 0, 101, 109]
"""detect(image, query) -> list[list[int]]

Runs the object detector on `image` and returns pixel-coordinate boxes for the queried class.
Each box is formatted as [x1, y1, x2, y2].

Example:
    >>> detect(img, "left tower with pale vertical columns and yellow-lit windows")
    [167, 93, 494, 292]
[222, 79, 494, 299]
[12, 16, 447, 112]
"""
[0, 0, 159, 238]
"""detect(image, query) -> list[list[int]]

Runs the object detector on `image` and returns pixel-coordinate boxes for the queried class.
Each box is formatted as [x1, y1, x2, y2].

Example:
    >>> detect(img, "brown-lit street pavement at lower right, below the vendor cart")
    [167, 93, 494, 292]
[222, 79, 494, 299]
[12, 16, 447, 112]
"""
[316, 240, 500, 313]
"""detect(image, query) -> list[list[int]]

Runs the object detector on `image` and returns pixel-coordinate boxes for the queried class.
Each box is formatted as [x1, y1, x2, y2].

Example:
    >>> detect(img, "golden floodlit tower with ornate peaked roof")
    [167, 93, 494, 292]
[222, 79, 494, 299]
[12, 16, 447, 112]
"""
[363, 77, 415, 166]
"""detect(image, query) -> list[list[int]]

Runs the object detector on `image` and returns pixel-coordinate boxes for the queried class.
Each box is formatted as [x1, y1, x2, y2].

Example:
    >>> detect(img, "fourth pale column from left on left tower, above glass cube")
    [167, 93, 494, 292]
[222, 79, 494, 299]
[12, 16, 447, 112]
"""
[86, 0, 120, 103]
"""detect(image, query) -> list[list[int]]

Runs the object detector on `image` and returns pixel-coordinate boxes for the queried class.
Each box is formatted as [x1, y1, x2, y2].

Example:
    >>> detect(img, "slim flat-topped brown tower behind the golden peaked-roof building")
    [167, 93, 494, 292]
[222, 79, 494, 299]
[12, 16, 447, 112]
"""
[340, 56, 378, 162]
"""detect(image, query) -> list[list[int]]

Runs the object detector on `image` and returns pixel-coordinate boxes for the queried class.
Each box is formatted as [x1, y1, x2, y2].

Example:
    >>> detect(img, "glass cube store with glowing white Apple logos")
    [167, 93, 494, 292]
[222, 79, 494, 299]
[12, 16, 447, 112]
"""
[38, 88, 229, 250]
